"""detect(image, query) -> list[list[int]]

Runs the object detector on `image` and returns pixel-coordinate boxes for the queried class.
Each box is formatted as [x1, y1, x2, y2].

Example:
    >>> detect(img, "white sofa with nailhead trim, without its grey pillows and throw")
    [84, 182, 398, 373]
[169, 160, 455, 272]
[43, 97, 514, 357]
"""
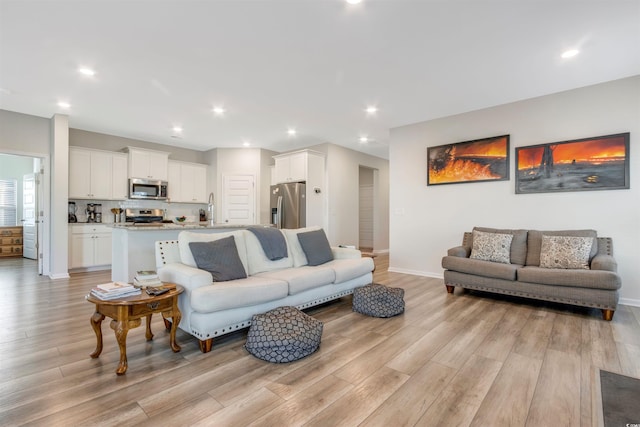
[155, 227, 374, 353]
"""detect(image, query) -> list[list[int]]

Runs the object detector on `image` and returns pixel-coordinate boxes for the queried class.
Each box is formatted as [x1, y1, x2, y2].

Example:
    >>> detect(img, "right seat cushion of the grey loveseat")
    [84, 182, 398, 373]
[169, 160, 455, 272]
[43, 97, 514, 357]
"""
[517, 266, 621, 290]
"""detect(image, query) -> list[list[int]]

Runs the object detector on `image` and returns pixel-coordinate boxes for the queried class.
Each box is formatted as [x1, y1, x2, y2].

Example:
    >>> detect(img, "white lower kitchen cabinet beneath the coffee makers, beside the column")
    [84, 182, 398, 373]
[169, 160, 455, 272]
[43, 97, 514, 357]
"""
[69, 224, 111, 268]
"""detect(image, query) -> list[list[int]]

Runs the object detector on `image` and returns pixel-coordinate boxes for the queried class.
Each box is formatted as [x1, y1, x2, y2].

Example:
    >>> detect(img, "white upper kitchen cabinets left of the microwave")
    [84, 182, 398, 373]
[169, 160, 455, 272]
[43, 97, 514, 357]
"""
[69, 147, 127, 200]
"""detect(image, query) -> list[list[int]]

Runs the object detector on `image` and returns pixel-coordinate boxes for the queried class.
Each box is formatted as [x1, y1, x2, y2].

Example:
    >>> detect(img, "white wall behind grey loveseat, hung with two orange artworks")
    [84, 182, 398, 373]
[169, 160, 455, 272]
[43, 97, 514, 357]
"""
[389, 76, 640, 305]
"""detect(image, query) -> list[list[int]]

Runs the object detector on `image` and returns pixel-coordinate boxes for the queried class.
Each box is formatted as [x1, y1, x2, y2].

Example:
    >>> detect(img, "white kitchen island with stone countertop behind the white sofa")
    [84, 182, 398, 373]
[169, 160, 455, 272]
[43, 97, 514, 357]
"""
[111, 222, 258, 283]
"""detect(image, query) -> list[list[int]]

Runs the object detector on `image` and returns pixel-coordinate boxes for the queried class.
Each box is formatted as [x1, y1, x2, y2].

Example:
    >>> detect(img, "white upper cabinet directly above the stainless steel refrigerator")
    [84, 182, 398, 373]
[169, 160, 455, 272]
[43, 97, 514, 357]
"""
[273, 150, 324, 184]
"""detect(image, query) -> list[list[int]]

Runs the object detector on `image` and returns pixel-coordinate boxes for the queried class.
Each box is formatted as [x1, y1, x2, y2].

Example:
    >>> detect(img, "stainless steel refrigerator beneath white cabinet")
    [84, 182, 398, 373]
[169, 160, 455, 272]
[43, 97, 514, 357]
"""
[271, 182, 307, 228]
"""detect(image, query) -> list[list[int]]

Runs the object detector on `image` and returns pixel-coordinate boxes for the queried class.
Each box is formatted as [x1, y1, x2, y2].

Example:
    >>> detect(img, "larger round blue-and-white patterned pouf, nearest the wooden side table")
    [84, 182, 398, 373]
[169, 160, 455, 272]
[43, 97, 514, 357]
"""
[245, 307, 323, 363]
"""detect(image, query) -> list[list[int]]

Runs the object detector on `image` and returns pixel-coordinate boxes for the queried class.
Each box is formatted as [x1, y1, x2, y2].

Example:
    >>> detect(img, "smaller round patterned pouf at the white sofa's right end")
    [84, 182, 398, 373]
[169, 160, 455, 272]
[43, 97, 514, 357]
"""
[353, 283, 404, 317]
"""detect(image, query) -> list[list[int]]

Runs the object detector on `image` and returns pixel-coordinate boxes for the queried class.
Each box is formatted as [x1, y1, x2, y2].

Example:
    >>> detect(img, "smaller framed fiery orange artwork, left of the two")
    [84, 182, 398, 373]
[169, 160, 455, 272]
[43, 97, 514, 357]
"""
[427, 135, 509, 185]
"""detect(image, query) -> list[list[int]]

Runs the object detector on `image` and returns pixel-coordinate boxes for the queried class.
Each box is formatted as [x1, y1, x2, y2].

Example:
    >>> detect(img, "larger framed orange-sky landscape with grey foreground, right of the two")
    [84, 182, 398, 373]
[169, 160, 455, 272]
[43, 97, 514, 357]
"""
[516, 133, 629, 194]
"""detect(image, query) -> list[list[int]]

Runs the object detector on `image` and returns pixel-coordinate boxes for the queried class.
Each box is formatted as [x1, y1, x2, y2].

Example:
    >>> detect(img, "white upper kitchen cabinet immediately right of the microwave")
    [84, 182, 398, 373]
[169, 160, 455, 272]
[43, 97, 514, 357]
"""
[168, 160, 207, 203]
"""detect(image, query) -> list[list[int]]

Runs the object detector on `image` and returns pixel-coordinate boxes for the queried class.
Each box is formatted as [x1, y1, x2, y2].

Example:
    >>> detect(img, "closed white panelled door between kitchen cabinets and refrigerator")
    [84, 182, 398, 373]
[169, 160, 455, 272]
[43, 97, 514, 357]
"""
[218, 175, 256, 225]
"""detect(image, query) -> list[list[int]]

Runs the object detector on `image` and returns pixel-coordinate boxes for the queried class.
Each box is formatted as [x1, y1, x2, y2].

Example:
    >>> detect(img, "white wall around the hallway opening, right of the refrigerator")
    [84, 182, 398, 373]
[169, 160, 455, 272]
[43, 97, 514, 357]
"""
[309, 144, 389, 252]
